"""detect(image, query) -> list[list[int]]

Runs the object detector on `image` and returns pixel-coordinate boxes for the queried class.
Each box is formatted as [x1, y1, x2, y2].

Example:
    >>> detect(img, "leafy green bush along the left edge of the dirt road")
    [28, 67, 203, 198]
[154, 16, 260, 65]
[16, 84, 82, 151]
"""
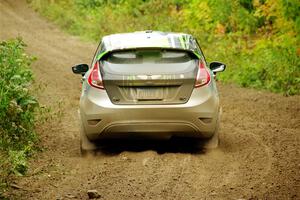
[0, 38, 38, 191]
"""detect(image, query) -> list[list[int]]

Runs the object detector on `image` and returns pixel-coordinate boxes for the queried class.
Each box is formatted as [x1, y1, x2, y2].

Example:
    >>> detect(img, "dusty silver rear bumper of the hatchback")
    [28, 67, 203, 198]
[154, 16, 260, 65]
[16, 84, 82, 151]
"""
[80, 85, 219, 140]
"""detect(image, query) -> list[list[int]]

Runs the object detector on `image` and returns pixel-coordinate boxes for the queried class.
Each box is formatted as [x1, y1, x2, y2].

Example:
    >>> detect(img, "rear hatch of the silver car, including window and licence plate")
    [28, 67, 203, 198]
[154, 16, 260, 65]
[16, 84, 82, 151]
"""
[100, 49, 198, 104]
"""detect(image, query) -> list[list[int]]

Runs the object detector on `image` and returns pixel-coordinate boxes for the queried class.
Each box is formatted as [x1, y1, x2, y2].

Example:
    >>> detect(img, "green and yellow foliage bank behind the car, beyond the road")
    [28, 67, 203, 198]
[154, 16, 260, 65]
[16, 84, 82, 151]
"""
[31, 0, 300, 95]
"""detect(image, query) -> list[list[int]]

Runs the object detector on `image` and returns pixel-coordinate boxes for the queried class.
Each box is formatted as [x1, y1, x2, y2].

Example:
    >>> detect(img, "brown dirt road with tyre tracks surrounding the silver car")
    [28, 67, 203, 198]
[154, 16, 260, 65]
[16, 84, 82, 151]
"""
[0, 0, 300, 200]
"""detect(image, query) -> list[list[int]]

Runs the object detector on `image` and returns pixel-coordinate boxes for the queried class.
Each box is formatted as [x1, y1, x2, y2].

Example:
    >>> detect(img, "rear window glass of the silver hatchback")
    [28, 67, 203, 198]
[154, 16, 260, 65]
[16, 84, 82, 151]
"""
[106, 50, 193, 64]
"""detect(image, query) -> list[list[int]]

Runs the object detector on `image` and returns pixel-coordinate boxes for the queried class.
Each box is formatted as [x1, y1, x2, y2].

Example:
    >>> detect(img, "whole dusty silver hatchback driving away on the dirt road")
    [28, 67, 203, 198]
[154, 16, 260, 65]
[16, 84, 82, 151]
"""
[72, 31, 226, 152]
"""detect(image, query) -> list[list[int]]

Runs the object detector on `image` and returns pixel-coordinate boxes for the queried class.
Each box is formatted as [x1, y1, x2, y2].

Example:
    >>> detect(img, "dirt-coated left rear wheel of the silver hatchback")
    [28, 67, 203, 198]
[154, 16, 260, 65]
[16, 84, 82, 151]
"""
[80, 124, 97, 156]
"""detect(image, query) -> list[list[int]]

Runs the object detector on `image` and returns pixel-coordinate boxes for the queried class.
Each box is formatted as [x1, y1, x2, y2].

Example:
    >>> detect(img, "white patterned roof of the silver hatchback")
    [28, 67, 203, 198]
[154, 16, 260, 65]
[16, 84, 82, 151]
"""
[99, 30, 201, 58]
